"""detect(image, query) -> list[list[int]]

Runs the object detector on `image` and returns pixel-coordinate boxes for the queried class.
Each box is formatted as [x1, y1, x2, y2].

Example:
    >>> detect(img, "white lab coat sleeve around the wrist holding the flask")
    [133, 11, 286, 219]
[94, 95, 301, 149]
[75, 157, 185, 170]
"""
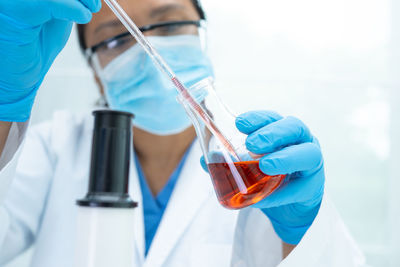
[231, 195, 366, 267]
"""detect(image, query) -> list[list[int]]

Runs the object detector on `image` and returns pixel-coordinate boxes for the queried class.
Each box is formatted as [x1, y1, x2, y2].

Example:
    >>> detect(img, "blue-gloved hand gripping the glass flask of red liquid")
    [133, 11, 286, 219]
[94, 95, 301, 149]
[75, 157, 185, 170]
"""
[236, 111, 325, 245]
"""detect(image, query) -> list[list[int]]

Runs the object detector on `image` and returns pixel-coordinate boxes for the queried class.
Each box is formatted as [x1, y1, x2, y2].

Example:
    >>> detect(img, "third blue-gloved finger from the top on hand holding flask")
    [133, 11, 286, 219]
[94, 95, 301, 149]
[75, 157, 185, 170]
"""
[259, 143, 323, 175]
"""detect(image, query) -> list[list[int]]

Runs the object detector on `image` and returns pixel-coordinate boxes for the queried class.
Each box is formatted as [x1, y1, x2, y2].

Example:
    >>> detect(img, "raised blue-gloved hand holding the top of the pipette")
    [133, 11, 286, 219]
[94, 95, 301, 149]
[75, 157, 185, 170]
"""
[0, 0, 101, 121]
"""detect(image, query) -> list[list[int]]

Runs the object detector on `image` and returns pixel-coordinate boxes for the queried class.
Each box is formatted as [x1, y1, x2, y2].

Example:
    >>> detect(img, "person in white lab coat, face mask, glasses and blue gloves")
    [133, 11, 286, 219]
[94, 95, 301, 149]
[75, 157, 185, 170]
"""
[0, 0, 363, 267]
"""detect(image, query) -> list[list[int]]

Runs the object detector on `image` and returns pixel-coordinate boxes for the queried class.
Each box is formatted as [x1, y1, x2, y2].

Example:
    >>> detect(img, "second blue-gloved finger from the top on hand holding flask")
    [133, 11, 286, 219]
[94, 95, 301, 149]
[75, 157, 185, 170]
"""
[246, 117, 313, 154]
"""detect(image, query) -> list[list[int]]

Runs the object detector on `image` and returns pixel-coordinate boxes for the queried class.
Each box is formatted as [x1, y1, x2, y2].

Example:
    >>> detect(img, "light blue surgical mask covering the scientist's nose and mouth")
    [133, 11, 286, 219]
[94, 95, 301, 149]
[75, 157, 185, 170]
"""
[98, 35, 213, 135]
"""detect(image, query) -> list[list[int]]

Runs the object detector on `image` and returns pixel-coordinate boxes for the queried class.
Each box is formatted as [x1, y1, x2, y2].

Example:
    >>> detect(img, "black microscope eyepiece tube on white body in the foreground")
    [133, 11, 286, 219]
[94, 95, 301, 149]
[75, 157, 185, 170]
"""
[74, 110, 137, 267]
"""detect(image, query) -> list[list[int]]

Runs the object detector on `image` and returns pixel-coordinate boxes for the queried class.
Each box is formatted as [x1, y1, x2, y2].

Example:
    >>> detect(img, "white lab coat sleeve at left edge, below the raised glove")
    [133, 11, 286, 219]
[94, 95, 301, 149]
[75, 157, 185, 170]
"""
[0, 124, 52, 266]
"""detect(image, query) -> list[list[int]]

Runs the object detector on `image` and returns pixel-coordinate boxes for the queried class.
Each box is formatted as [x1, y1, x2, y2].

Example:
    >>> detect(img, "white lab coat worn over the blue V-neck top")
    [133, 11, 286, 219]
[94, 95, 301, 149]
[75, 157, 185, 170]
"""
[0, 112, 364, 267]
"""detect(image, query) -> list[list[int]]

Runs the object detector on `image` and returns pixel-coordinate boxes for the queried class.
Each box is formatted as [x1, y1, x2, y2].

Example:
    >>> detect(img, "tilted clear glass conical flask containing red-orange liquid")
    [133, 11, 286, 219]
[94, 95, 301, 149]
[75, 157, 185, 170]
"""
[178, 78, 285, 209]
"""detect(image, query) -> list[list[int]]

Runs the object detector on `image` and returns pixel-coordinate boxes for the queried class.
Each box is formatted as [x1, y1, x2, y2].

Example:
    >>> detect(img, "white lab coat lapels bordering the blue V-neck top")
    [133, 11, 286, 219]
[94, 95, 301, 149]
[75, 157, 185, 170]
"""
[139, 141, 213, 267]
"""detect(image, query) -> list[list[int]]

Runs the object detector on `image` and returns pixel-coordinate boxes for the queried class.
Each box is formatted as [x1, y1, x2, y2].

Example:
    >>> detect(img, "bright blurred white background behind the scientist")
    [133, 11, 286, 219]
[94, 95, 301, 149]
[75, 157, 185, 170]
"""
[7, 0, 400, 267]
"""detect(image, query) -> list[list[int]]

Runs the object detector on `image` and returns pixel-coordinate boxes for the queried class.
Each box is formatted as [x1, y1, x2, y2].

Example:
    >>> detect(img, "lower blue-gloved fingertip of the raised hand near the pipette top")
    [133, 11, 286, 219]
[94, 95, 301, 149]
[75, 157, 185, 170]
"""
[46, 0, 92, 24]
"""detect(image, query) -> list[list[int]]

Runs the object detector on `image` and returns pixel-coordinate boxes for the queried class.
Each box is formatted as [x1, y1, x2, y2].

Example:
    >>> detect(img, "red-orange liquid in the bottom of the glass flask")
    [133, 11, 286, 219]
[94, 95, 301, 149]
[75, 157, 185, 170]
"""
[208, 161, 285, 209]
